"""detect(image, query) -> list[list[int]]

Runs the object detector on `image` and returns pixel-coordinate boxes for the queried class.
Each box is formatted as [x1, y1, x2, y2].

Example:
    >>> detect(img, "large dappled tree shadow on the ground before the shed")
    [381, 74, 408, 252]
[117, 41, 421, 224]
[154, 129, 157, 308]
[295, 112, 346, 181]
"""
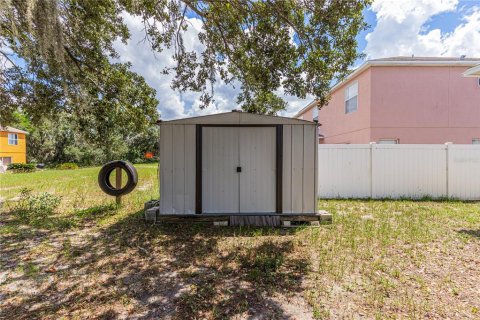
[0, 209, 309, 319]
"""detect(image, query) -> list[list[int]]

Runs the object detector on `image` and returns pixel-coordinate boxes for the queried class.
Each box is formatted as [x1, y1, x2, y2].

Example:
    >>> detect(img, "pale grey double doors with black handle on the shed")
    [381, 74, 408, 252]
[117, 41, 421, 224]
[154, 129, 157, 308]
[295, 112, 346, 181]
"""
[202, 127, 277, 214]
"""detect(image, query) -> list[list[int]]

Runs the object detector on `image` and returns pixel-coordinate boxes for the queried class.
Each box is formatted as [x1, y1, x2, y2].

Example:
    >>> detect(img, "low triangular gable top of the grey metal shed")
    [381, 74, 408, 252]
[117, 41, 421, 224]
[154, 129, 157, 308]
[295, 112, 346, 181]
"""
[161, 111, 315, 125]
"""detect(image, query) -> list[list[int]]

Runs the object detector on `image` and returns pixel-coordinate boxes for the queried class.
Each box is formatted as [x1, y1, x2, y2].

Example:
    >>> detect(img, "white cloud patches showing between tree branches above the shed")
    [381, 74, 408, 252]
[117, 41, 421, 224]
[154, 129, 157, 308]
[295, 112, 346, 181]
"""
[115, 14, 312, 120]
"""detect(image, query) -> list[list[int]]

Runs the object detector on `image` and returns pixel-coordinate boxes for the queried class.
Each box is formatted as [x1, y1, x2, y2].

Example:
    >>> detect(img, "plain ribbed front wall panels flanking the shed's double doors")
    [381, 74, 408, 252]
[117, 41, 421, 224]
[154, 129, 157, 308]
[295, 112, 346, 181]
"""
[160, 124, 317, 214]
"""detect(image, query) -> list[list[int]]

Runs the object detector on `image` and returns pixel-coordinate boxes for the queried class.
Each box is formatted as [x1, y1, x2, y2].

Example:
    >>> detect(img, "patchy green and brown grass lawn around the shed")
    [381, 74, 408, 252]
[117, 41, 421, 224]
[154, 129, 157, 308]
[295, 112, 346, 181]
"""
[0, 165, 480, 319]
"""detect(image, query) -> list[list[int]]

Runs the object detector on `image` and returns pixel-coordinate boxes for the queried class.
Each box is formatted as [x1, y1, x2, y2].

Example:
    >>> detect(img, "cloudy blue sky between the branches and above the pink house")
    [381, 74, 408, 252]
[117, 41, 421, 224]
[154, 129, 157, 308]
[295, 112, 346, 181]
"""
[115, 0, 480, 120]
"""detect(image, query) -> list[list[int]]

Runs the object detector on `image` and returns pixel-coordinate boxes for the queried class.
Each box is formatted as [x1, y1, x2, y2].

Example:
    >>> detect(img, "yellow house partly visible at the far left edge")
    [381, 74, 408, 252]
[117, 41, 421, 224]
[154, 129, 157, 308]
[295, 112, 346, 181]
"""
[0, 126, 28, 165]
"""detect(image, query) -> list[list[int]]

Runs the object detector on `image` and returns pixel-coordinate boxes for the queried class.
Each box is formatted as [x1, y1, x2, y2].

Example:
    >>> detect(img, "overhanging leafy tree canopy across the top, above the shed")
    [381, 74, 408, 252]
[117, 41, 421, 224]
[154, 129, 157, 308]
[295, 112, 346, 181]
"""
[0, 0, 370, 122]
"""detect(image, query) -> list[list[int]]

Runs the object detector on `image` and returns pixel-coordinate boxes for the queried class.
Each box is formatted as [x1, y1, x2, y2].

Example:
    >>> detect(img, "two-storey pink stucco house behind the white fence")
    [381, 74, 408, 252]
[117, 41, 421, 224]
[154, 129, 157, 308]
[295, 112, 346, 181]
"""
[295, 57, 480, 144]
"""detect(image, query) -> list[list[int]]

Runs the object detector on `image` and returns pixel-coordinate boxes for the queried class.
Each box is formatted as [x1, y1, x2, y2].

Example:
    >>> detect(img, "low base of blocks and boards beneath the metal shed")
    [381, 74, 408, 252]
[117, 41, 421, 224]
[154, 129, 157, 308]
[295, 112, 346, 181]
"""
[145, 206, 332, 227]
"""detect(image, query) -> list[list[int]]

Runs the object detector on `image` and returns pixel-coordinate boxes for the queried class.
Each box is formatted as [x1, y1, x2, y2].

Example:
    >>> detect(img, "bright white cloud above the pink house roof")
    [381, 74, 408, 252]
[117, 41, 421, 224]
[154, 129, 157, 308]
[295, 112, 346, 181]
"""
[365, 0, 480, 59]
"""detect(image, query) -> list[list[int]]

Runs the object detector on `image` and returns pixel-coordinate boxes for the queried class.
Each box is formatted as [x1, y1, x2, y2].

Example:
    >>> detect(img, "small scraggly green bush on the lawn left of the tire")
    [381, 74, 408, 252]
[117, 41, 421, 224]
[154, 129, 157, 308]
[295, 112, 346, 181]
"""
[14, 188, 61, 222]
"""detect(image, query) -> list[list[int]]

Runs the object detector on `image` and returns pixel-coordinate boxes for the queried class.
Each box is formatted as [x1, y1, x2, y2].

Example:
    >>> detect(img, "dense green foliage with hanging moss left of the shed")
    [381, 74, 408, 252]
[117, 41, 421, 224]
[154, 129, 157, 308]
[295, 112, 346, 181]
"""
[0, 0, 159, 143]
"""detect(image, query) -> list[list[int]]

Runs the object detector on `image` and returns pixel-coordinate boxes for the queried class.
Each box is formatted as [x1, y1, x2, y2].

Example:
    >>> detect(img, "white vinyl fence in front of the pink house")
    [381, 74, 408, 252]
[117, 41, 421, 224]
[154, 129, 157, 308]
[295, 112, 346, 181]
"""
[318, 143, 480, 200]
